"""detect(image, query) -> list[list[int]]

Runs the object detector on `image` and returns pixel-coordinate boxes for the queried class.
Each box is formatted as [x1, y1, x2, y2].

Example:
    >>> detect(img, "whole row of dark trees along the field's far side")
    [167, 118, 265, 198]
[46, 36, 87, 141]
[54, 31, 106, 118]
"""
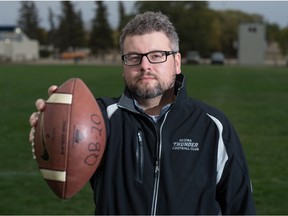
[17, 1, 288, 58]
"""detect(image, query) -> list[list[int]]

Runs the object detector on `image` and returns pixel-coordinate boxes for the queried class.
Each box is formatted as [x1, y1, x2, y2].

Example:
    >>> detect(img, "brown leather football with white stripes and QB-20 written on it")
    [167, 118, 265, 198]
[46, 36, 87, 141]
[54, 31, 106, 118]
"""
[32, 78, 106, 199]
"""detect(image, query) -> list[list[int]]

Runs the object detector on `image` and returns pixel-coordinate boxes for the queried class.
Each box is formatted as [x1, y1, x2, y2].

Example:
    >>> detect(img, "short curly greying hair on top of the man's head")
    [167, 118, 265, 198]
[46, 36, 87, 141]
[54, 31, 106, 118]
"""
[119, 11, 179, 54]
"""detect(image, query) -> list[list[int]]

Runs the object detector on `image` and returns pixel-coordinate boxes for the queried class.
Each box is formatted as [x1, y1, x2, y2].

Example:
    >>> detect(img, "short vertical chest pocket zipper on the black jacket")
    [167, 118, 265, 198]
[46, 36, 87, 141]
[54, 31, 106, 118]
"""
[136, 129, 144, 184]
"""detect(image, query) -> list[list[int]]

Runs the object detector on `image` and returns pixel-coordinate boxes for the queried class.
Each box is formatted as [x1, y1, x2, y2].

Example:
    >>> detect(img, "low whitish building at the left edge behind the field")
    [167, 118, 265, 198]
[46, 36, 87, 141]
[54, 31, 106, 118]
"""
[0, 26, 39, 62]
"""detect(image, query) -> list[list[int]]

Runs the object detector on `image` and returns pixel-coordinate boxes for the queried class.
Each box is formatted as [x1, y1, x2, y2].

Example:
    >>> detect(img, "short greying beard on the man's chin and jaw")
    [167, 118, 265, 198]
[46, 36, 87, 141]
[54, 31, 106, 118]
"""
[124, 74, 176, 99]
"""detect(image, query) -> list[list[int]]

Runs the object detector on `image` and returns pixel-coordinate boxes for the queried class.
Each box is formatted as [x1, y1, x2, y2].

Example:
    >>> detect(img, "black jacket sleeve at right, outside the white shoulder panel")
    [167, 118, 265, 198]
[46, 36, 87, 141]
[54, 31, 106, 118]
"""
[216, 122, 256, 215]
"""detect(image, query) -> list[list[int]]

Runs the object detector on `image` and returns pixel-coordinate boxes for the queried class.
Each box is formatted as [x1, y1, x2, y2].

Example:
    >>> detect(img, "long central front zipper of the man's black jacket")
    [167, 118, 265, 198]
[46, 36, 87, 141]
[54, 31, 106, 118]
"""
[151, 111, 169, 215]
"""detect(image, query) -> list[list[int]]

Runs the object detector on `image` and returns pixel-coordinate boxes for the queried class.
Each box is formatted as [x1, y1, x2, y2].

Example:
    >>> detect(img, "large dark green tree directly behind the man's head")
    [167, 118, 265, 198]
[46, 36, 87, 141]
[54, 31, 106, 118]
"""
[135, 1, 212, 54]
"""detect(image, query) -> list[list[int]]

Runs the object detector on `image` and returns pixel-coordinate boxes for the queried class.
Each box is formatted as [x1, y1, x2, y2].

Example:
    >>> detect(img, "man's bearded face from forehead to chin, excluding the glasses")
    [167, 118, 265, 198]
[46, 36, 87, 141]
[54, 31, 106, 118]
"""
[123, 32, 181, 98]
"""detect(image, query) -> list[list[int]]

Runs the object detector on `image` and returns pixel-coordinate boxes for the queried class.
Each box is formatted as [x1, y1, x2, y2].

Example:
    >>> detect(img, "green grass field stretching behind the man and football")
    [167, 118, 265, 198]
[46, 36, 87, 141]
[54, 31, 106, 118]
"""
[0, 65, 288, 215]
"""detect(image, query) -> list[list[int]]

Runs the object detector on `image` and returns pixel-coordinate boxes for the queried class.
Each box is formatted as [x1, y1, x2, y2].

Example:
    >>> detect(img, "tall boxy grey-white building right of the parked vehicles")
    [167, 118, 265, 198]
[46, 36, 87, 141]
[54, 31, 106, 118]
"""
[238, 23, 266, 65]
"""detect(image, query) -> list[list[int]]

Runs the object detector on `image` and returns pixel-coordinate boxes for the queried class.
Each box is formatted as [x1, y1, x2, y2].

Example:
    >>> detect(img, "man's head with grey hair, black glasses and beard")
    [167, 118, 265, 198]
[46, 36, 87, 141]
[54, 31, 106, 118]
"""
[120, 12, 181, 101]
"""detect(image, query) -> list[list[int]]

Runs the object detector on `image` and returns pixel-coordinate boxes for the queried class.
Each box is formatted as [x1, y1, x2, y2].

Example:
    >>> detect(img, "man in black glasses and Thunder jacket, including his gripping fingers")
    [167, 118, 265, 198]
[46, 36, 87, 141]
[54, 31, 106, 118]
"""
[30, 12, 256, 215]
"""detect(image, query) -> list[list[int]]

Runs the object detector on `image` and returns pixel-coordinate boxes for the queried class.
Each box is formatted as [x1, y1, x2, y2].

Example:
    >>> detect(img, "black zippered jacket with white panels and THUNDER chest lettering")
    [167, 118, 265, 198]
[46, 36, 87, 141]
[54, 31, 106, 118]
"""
[91, 74, 256, 215]
